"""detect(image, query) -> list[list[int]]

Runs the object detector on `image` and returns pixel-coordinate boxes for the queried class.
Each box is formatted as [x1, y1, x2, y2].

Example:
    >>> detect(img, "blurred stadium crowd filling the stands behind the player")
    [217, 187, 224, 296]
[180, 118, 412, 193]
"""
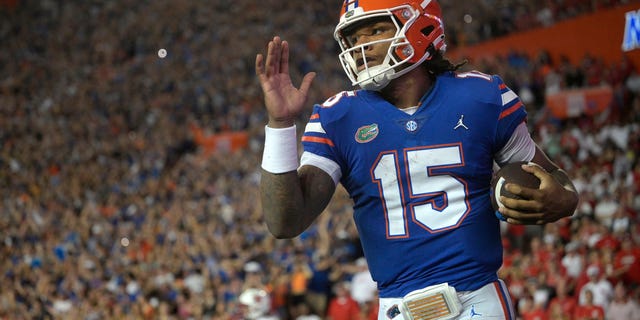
[0, 0, 640, 320]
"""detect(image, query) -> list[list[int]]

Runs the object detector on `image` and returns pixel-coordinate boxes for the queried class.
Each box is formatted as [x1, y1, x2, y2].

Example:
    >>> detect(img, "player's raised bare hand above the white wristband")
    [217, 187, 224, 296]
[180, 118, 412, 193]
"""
[256, 37, 315, 125]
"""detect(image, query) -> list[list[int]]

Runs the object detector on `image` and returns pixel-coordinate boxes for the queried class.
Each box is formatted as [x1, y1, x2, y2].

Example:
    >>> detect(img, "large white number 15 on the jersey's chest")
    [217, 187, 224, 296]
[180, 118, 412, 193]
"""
[371, 144, 469, 238]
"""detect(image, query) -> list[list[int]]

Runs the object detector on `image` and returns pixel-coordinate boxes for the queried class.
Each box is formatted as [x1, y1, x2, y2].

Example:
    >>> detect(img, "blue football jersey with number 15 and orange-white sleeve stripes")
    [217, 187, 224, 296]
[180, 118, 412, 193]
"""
[302, 72, 526, 298]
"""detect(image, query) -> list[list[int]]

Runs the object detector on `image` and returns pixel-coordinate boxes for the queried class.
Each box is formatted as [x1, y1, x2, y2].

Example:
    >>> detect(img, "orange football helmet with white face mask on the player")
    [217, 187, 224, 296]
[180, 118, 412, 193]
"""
[334, 0, 446, 90]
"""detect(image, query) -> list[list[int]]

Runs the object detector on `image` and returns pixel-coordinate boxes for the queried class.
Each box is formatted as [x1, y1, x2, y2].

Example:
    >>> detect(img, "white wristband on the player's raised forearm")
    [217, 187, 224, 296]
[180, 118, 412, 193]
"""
[262, 125, 298, 173]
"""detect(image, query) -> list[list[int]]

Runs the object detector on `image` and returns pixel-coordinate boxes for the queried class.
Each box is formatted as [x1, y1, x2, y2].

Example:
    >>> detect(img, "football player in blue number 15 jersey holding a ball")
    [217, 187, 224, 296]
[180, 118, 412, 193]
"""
[256, 0, 578, 319]
